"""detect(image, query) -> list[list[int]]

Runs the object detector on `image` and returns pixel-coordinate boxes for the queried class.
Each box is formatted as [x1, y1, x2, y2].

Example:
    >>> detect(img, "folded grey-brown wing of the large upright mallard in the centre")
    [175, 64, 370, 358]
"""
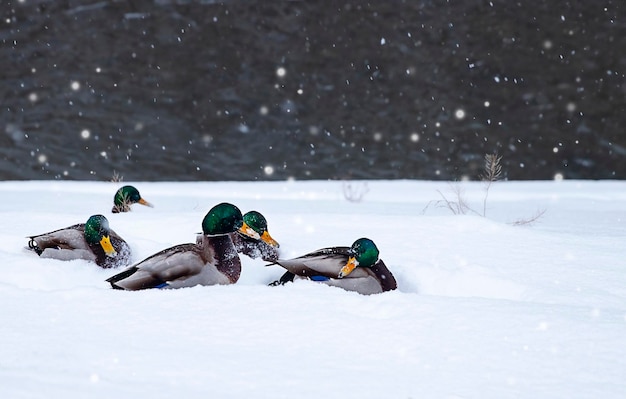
[106, 244, 206, 290]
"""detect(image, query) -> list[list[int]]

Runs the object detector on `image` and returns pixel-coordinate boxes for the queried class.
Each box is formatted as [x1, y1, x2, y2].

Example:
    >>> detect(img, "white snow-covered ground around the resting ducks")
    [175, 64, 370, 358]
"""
[0, 181, 626, 399]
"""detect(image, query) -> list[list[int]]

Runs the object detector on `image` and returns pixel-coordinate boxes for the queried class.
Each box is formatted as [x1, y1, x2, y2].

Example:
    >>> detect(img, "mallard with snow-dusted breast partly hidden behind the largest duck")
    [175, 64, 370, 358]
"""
[196, 211, 280, 262]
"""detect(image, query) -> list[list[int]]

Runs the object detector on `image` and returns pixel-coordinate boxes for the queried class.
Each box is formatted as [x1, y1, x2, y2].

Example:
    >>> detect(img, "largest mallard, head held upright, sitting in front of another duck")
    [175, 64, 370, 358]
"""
[106, 203, 260, 290]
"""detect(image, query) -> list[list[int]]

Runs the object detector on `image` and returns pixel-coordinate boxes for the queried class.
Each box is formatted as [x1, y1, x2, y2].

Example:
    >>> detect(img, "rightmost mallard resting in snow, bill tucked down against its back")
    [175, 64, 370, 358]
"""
[270, 238, 398, 295]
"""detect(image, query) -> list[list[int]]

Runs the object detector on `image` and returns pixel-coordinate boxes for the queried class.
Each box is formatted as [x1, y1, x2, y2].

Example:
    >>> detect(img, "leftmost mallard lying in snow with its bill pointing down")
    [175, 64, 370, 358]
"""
[28, 215, 131, 268]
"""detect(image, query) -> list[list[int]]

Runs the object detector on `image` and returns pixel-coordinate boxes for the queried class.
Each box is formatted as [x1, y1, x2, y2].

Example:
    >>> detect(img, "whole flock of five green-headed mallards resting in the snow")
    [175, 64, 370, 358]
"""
[28, 186, 397, 295]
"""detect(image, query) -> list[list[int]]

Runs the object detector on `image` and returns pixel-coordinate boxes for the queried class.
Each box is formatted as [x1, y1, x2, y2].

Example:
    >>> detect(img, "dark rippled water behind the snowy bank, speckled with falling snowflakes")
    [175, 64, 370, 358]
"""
[0, 0, 626, 180]
